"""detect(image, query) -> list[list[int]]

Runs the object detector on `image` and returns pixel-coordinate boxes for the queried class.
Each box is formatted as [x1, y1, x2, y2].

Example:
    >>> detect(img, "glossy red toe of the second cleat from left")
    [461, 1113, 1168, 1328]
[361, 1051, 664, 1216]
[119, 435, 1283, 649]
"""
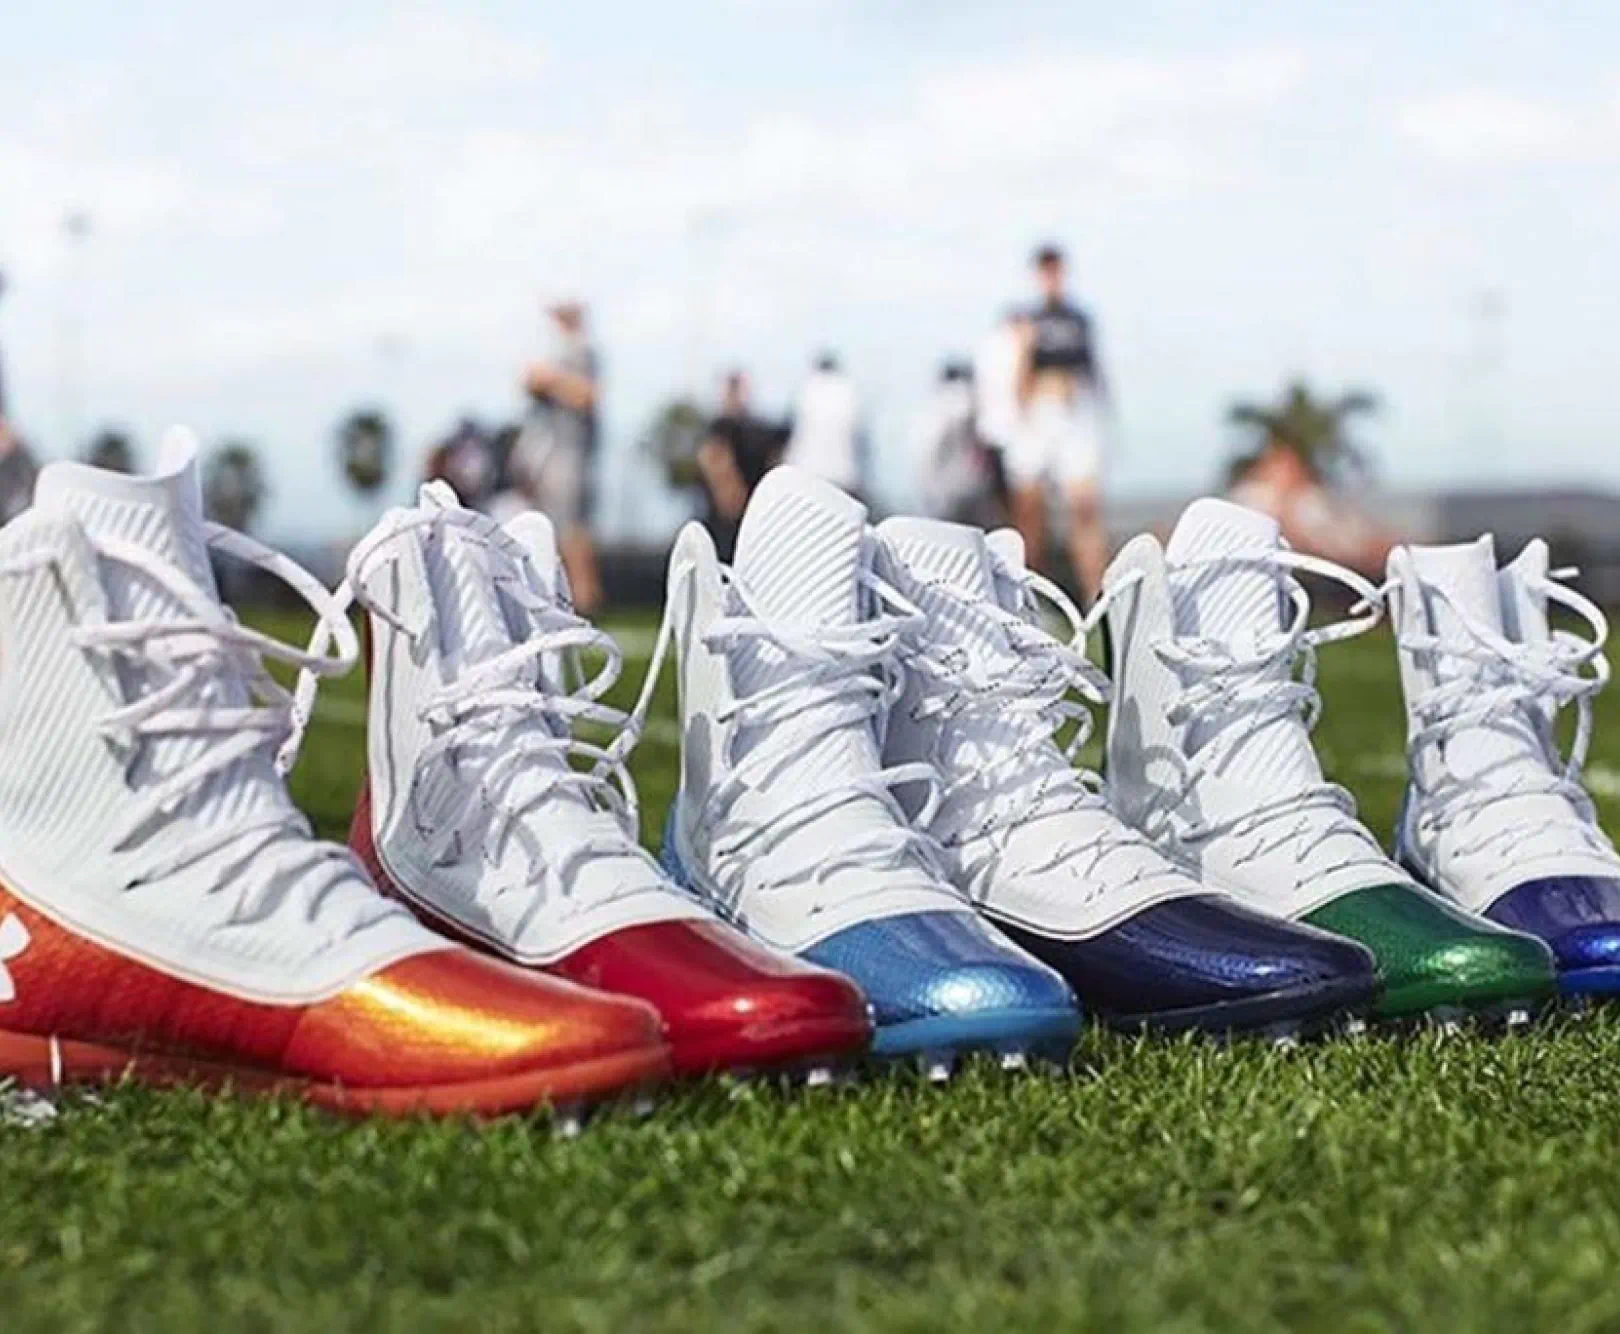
[551, 919, 872, 1073]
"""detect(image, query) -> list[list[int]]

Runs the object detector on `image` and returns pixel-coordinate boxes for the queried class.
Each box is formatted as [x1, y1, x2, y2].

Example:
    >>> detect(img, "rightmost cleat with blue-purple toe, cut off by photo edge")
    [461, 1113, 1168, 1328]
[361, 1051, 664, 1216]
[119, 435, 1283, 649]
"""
[1385, 535, 1620, 995]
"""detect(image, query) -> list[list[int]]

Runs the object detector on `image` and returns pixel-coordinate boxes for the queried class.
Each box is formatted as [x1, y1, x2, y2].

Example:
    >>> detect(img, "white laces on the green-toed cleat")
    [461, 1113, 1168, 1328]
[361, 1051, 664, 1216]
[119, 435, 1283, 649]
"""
[1087, 548, 1385, 888]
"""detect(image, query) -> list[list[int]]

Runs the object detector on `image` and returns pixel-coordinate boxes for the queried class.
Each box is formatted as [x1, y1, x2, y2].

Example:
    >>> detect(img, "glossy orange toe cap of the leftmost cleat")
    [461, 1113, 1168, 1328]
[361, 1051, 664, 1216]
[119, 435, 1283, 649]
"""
[285, 947, 667, 1088]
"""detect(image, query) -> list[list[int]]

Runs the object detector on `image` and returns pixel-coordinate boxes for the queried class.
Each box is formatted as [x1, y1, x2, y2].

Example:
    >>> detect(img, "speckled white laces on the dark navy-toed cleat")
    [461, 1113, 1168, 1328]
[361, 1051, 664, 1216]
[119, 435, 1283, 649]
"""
[904, 571, 1170, 896]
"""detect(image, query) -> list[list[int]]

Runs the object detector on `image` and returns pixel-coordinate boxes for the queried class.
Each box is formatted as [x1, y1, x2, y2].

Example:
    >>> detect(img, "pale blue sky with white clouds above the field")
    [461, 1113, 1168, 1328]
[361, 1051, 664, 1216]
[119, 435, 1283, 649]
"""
[0, 0, 1620, 538]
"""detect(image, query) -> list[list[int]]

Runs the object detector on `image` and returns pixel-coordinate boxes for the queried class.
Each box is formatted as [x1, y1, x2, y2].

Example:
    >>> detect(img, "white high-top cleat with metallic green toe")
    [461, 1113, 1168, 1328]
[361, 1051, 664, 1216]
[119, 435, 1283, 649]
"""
[1103, 499, 1552, 1018]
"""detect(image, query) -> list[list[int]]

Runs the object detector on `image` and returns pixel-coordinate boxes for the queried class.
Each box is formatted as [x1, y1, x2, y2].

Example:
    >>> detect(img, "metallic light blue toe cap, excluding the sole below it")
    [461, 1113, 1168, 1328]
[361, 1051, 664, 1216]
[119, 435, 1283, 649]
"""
[804, 913, 1076, 1029]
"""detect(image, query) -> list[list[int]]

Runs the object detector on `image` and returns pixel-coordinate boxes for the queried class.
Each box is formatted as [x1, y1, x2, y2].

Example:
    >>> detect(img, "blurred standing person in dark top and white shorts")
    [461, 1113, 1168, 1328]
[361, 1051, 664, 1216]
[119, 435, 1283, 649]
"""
[1006, 245, 1108, 601]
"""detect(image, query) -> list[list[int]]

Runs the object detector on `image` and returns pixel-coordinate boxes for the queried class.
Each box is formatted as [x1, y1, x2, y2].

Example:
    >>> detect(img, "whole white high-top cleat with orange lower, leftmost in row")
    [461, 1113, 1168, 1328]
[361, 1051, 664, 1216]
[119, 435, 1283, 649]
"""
[0, 443, 669, 1114]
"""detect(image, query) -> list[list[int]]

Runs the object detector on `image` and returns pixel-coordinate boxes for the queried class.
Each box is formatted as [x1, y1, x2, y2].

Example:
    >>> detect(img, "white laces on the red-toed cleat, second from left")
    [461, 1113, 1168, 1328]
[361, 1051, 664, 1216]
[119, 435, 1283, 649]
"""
[280, 509, 663, 930]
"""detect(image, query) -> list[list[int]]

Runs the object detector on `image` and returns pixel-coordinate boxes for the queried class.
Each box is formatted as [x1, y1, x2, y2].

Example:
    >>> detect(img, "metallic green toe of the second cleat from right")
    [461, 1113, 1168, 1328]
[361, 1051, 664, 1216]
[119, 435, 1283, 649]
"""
[1306, 883, 1554, 1018]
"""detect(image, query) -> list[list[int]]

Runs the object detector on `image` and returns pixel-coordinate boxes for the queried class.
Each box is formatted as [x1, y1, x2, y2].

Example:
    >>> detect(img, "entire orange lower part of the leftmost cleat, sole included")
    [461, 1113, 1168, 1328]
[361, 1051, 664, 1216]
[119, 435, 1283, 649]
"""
[0, 888, 671, 1115]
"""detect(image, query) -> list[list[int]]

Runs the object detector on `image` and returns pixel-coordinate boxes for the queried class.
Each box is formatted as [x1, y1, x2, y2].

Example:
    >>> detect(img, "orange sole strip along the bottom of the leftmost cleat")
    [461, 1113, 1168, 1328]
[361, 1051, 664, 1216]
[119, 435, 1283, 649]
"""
[0, 1031, 671, 1117]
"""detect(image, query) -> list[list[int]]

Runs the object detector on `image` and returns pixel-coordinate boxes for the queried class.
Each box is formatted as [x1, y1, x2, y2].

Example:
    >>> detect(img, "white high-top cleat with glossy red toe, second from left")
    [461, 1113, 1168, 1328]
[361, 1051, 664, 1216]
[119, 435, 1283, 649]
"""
[305, 483, 872, 1075]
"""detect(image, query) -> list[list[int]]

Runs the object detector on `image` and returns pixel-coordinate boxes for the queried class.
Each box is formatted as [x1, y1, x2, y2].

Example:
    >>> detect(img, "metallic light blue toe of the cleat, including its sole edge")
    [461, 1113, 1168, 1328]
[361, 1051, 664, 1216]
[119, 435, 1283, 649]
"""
[799, 911, 1081, 1060]
